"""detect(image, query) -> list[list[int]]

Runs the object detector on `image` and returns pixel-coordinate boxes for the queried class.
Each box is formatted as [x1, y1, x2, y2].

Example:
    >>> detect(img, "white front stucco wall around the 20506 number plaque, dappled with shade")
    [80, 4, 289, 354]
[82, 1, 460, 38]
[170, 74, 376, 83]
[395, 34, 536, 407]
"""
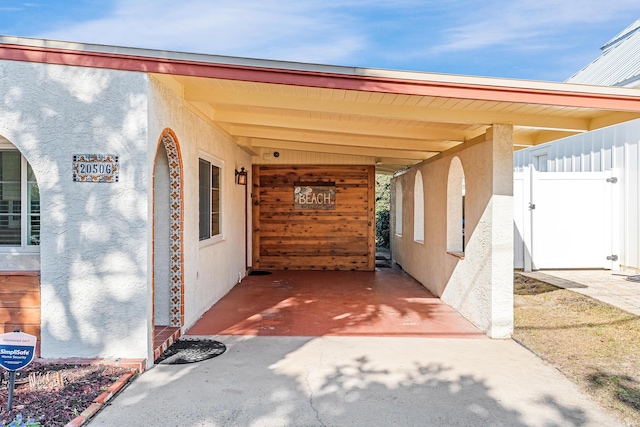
[0, 61, 149, 357]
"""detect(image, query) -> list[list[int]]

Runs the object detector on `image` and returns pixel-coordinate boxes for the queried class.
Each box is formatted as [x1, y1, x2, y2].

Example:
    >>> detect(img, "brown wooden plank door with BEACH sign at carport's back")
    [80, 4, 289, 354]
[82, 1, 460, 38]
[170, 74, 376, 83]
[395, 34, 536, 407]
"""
[251, 165, 375, 271]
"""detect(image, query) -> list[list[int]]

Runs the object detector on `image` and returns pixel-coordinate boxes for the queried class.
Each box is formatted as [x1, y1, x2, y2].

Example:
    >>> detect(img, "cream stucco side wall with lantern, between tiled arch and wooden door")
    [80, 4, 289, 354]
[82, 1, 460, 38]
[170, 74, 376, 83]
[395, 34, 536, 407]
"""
[149, 78, 251, 334]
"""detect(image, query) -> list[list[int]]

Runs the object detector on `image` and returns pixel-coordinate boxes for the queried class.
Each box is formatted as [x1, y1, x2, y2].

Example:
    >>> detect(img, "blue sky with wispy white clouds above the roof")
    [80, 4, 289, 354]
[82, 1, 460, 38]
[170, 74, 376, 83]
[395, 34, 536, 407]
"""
[0, 0, 640, 81]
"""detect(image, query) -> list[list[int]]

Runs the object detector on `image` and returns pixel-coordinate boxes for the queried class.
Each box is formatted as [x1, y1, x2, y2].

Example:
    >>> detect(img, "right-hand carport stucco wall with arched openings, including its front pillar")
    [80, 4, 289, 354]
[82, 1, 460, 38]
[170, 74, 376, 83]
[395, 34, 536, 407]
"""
[391, 125, 513, 338]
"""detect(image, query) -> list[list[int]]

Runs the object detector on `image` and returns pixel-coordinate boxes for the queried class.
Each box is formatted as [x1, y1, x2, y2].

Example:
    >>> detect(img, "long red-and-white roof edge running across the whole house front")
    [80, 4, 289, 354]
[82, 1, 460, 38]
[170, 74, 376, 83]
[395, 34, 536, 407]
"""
[0, 36, 640, 112]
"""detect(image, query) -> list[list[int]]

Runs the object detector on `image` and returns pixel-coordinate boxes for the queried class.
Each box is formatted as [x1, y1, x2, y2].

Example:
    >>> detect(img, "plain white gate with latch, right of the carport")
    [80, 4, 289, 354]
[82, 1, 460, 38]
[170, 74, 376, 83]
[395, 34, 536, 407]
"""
[514, 168, 617, 271]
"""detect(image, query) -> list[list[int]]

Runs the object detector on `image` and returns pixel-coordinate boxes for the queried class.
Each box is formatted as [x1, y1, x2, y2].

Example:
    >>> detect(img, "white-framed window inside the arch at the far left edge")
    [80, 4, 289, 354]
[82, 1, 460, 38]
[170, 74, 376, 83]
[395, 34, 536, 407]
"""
[0, 151, 40, 249]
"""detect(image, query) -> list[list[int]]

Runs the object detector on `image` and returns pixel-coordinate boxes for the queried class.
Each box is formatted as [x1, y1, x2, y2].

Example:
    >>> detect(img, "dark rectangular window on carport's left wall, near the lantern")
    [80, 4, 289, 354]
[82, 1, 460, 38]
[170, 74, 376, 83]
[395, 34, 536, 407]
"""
[198, 159, 222, 240]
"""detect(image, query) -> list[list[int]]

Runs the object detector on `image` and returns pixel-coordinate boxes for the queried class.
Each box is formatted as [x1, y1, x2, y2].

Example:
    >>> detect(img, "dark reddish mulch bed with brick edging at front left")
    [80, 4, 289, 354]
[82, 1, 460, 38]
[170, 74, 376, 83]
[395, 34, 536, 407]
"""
[0, 363, 131, 427]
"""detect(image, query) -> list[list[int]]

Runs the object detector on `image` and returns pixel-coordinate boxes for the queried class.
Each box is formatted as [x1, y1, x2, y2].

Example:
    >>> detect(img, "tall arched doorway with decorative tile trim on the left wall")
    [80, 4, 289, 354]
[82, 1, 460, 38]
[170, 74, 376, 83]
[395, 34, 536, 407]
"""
[152, 129, 184, 346]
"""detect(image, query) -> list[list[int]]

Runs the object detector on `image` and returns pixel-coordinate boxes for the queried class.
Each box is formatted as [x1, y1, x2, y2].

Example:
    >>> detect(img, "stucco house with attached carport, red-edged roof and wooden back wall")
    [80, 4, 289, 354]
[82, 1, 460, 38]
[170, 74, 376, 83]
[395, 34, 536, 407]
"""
[0, 37, 640, 361]
